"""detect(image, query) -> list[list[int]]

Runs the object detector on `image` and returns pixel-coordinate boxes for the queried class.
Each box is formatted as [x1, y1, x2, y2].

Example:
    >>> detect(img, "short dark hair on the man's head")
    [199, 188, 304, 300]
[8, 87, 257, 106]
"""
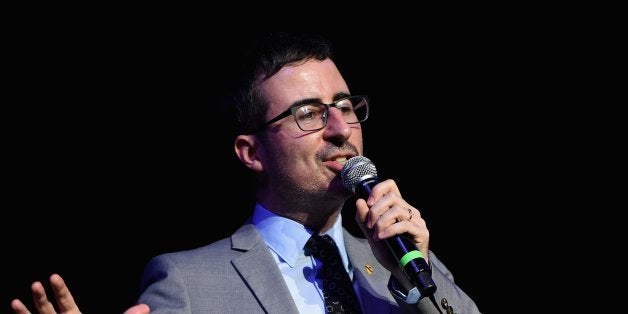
[225, 32, 333, 135]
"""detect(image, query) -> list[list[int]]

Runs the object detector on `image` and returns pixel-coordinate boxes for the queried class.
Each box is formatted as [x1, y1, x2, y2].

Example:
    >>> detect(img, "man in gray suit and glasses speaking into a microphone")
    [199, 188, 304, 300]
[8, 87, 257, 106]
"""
[14, 33, 479, 313]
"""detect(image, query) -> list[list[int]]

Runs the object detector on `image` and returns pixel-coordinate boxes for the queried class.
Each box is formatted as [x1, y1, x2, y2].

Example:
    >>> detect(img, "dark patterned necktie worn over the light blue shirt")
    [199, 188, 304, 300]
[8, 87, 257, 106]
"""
[305, 235, 362, 313]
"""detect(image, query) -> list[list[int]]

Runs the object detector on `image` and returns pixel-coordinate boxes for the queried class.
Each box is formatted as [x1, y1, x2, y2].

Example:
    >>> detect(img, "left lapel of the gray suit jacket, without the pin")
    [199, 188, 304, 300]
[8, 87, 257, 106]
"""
[231, 225, 298, 313]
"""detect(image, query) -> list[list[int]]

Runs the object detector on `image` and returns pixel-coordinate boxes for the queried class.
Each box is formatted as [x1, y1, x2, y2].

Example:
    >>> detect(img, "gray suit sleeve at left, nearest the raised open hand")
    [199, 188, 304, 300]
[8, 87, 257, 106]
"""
[138, 254, 192, 314]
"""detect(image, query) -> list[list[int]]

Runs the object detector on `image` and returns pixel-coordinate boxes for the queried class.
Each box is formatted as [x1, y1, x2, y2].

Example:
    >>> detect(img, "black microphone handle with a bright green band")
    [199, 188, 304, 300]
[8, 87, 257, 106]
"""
[355, 178, 436, 297]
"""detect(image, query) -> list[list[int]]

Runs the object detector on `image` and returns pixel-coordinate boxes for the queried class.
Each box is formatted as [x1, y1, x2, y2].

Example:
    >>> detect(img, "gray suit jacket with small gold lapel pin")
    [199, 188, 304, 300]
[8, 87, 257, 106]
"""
[138, 224, 479, 314]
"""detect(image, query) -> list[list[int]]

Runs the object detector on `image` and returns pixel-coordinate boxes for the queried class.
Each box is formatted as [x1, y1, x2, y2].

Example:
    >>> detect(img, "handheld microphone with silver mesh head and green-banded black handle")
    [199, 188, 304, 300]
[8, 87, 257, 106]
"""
[340, 156, 436, 297]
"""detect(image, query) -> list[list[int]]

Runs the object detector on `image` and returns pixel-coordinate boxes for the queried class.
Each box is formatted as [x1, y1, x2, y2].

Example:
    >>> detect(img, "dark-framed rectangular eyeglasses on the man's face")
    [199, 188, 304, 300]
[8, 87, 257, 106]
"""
[252, 95, 369, 133]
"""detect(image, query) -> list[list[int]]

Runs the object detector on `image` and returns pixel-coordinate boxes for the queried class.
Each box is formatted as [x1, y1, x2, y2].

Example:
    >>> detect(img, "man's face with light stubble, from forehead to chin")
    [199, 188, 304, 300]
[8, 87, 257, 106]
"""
[259, 59, 362, 196]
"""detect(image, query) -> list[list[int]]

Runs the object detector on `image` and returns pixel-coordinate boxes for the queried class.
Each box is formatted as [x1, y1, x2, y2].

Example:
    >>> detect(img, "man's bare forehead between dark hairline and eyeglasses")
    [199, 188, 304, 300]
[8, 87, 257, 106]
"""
[260, 59, 349, 114]
